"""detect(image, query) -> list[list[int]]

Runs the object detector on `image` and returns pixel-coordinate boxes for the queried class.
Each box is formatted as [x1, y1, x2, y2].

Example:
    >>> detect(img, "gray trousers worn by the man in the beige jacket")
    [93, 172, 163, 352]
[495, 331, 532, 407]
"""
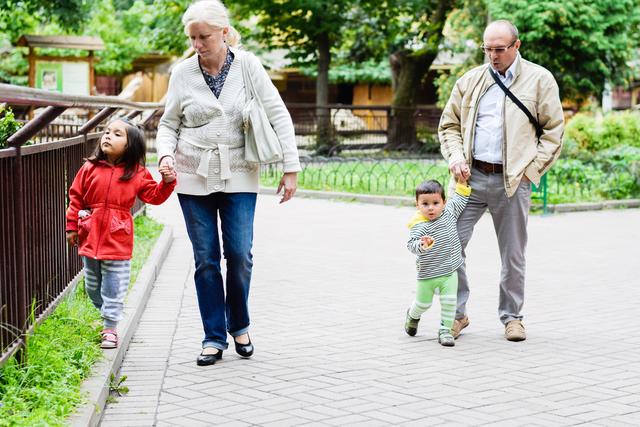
[456, 168, 531, 324]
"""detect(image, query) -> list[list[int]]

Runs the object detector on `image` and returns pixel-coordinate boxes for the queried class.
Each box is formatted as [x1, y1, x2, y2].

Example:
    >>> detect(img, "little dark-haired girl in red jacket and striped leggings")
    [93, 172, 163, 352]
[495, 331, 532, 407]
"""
[66, 119, 176, 348]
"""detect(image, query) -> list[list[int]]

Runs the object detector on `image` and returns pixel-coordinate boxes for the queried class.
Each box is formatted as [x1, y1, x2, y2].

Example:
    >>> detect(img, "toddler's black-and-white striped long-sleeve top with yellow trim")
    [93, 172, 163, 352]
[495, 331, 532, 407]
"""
[407, 184, 471, 280]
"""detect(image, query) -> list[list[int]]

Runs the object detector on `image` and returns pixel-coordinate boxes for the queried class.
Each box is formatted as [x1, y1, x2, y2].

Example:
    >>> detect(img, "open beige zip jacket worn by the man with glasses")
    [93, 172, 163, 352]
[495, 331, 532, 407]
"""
[438, 58, 564, 197]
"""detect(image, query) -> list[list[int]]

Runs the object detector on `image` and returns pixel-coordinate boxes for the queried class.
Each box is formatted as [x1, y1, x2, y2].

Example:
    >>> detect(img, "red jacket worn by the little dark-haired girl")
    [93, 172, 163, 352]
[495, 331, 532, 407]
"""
[66, 161, 176, 260]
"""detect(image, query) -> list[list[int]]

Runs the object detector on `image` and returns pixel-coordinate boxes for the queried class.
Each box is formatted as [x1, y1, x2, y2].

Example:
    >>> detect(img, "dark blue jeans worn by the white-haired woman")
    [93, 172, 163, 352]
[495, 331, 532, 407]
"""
[178, 193, 257, 350]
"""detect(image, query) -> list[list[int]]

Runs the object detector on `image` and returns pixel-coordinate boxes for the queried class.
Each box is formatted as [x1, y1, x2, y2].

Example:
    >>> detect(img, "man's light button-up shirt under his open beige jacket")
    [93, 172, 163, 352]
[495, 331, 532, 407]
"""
[473, 53, 520, 164]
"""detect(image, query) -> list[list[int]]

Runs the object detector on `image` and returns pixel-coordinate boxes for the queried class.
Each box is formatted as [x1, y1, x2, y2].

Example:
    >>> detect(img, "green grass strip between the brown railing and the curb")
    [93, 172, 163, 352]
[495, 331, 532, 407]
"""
[0, 216, 162, 426]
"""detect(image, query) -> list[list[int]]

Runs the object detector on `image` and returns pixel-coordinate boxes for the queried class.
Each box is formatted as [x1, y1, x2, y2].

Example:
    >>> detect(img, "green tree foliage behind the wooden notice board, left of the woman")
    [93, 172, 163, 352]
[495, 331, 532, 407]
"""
[0, 0, 191, 84]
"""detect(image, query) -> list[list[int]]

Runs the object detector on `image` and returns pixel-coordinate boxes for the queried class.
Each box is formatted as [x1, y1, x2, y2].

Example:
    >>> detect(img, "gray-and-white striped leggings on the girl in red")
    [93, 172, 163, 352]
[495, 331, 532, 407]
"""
[82, 256, 131, 328]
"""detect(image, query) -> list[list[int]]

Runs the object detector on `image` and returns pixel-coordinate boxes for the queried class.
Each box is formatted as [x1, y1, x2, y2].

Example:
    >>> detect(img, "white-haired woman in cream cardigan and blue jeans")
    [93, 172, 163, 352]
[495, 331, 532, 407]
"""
[157, 0, 300, 365]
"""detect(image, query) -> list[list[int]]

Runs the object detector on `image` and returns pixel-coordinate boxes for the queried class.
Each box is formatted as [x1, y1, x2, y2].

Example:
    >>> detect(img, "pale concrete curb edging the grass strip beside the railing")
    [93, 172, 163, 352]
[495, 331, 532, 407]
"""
[67, 225, 173, 427]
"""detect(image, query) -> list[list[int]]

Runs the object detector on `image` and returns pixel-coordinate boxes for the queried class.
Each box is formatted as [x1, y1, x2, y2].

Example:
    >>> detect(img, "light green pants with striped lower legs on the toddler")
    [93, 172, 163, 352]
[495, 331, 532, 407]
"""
[409, 271, 458, 330]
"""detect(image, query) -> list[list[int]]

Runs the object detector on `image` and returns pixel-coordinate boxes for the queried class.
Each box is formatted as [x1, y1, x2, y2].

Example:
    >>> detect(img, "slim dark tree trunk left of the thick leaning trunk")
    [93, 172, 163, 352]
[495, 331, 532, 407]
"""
[316, 33, 335, 155]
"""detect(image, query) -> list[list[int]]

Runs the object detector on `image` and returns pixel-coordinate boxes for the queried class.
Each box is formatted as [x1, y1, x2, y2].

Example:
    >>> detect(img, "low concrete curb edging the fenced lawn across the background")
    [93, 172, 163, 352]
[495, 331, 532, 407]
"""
[260, 187, 640, 213]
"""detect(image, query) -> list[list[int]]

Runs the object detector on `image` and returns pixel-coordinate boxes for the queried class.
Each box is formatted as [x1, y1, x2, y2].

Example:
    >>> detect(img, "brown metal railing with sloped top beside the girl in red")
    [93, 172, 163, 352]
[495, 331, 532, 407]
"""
[0, 84, 163, 365]
